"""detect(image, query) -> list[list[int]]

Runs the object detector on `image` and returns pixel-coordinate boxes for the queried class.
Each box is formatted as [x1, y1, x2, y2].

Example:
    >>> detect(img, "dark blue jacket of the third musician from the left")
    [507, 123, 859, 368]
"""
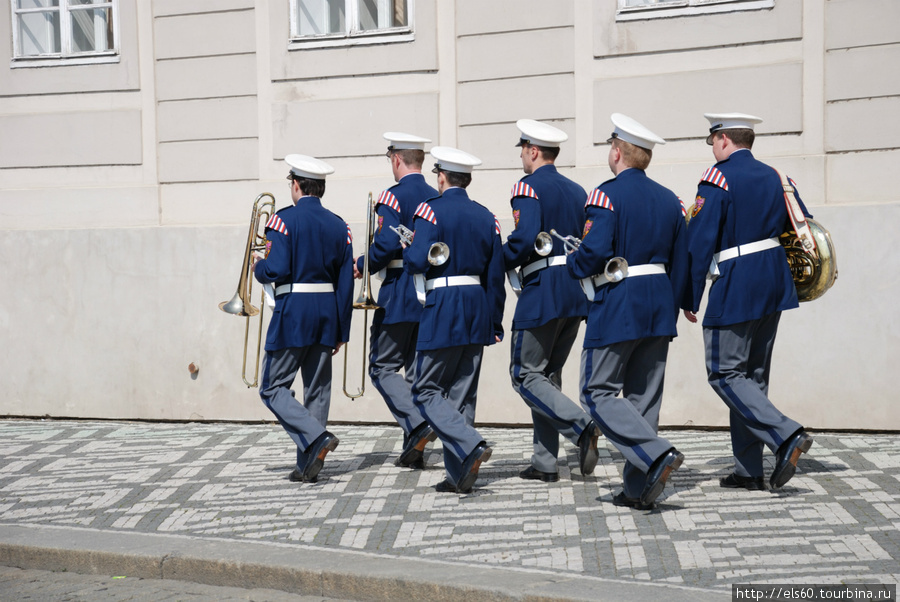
[403, 188, 506, 350]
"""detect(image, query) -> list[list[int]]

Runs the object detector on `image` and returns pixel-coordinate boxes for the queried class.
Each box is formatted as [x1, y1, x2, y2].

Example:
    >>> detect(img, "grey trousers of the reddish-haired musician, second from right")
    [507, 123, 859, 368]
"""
[581, 337, 673, 498]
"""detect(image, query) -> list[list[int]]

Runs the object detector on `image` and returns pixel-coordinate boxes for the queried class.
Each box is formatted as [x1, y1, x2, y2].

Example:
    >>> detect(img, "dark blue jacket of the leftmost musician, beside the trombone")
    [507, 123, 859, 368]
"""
[255, 196, 353, 351]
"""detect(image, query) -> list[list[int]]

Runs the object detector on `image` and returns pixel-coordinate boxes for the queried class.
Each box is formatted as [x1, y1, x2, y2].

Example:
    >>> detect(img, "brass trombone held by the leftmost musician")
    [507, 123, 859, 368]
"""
[219, 192, 275, 387]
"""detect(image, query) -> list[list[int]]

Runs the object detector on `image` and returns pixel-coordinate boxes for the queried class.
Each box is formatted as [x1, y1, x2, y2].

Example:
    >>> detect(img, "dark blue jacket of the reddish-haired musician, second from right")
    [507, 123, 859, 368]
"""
[567, 168, 688, 348]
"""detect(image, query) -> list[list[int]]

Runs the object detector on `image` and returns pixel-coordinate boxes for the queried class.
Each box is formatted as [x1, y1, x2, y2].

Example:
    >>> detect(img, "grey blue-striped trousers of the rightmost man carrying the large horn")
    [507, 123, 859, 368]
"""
[703, 312, 803, 477]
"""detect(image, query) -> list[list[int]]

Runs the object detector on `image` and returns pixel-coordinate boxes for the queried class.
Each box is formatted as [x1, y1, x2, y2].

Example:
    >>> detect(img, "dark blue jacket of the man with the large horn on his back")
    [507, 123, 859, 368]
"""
[682, 149, 809, 327]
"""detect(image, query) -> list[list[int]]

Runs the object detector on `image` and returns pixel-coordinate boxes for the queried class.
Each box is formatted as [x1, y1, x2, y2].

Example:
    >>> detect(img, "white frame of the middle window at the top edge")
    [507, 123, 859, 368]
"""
[288, 0, 415, 50]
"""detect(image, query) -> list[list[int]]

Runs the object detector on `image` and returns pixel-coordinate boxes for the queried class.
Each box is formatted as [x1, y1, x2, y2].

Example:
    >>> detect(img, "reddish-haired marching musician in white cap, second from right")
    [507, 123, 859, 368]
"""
[567, 113, 688, 510]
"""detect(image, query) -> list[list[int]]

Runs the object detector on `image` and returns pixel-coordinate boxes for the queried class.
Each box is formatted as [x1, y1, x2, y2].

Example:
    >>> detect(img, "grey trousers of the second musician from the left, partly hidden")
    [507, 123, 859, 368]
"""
[369, 309, 425, 444]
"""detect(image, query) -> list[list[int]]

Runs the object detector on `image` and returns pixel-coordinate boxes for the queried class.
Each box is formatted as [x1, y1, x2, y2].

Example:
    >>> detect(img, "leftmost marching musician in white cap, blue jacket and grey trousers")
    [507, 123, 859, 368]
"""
[253, 155, 353, 483]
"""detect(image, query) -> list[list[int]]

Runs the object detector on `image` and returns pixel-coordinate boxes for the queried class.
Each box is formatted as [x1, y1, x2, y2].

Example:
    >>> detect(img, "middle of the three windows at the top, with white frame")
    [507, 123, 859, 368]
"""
[291, 0, 413, 47]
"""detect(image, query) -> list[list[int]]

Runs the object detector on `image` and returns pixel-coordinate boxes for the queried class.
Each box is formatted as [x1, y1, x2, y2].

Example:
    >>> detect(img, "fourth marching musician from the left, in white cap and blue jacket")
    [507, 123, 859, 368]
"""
[503, 119, 600, 482]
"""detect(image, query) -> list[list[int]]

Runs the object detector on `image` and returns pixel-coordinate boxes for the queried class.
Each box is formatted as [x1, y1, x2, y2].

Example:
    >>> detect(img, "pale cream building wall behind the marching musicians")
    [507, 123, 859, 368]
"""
[0, 0, 900, 429]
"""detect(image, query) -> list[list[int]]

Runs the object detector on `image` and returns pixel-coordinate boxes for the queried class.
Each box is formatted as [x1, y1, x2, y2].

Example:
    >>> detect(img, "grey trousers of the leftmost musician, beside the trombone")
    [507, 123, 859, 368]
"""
[259, 345, 333, 470]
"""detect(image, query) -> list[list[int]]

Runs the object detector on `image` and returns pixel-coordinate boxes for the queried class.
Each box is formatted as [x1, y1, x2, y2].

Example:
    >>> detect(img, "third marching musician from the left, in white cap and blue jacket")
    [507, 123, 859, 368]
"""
[403, 146, 506, 493]
